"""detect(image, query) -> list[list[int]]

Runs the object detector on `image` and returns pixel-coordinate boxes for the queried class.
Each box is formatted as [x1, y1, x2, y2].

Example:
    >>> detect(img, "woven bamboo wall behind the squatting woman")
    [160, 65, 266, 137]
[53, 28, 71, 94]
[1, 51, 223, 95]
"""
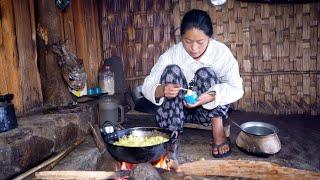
[101, 0, 320, 115]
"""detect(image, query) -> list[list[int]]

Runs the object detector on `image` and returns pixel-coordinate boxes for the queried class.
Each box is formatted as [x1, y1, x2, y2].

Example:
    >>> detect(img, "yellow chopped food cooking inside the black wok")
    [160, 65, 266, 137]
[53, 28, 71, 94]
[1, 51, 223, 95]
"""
[114, 134, 169, 147]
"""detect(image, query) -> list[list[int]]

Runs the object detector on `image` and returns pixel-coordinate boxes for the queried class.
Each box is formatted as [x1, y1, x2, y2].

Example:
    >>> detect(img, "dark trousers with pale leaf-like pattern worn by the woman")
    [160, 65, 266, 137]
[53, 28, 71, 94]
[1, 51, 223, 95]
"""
[156, 65, 230, 132]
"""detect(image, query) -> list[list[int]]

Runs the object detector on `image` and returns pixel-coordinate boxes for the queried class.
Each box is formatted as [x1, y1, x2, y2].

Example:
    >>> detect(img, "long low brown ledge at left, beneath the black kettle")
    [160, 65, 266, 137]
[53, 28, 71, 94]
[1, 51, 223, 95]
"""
[0, 104, 97, 179]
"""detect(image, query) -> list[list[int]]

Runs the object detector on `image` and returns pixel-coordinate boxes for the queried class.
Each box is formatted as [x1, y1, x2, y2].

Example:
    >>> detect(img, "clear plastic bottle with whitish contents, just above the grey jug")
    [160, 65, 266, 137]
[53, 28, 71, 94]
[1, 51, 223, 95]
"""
[99, 65, 114, 95]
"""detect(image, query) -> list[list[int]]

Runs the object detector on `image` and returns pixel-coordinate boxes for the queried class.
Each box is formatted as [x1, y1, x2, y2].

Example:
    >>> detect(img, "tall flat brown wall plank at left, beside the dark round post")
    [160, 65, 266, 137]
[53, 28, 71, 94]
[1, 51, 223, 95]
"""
[13, 0, 43, 112]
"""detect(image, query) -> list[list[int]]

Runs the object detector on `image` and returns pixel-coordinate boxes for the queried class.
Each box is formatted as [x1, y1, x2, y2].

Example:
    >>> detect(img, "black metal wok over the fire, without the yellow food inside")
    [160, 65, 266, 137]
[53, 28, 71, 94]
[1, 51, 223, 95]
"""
[101, 127, 178, 164]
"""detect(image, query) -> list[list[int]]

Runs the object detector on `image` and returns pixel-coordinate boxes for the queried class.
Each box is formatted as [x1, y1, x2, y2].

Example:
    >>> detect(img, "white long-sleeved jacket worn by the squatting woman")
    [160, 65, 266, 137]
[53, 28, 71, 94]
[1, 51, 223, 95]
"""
[142, 39, 244, 109]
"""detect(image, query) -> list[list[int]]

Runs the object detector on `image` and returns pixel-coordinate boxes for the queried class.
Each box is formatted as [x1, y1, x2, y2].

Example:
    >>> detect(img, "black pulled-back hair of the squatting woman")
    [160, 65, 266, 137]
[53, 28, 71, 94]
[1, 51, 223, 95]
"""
[180, 9, 213, 37]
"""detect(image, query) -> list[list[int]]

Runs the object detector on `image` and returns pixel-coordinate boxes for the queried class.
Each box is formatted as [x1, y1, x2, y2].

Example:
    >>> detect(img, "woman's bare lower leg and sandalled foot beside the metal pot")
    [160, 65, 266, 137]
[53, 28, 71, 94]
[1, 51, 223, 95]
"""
[212, 118, 231, 157]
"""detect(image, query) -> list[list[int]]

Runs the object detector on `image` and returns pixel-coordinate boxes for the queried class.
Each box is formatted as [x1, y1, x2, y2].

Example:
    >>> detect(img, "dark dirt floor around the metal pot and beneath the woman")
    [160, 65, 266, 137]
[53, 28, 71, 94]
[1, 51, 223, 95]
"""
[123, 111, 320, 172]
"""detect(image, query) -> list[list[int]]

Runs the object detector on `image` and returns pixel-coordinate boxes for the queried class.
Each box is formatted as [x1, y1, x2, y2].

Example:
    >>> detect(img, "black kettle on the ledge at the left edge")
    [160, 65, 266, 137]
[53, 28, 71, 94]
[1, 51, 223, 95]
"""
[0, 94, 18, 133]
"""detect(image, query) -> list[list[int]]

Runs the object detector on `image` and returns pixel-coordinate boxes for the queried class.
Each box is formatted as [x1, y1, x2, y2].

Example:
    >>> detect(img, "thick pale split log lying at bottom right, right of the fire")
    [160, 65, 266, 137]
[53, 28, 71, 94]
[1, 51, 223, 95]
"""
[177, 160, 320, 179]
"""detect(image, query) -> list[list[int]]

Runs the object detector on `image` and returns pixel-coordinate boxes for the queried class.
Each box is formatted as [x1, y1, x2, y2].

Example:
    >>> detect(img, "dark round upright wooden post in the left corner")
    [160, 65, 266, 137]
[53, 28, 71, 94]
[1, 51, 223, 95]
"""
[37, 0, 72, 106]
